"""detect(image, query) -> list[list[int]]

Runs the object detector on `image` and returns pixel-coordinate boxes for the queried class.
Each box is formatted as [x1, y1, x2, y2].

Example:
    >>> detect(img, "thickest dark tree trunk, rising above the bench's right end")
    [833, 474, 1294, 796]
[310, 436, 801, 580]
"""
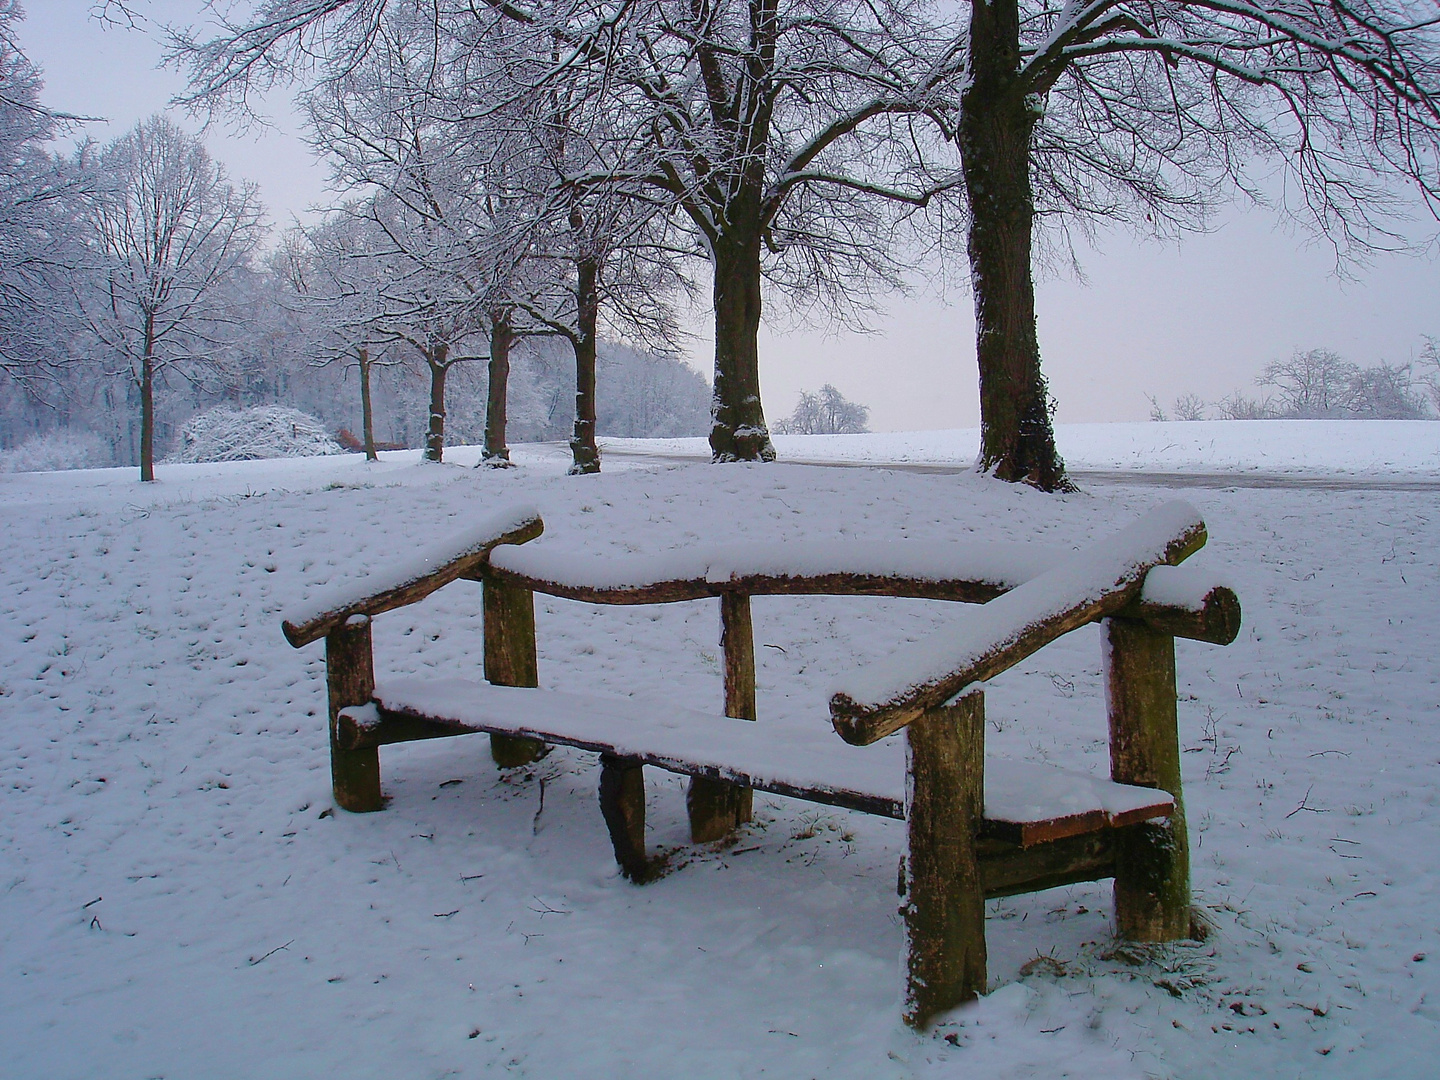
[959, 0, 1070, 491]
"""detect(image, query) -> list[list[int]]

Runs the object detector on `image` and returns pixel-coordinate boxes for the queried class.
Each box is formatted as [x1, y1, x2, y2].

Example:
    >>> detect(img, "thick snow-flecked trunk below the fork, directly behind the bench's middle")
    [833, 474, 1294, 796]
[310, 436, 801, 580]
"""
[710, 234, 775, 461]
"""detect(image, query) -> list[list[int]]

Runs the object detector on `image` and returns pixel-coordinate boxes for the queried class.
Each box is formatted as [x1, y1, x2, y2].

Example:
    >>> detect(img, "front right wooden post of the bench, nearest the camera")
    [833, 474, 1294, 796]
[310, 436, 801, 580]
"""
[900, 691, 986, 1030]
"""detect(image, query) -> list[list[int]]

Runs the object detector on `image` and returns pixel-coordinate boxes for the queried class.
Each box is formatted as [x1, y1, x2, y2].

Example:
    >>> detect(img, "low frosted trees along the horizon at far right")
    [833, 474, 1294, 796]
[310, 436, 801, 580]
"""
[1151, 351, 1440, 420]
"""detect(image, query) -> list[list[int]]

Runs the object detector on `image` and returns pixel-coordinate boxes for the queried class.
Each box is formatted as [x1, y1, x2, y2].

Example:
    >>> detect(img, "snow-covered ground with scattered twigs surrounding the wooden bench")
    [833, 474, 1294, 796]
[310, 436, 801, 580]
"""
[0, 422, 1440, 1080]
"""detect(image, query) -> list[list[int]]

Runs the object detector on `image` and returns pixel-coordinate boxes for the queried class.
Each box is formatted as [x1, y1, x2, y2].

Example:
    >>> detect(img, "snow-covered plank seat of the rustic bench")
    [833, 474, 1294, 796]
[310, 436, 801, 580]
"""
[338, 678, 1174, 845]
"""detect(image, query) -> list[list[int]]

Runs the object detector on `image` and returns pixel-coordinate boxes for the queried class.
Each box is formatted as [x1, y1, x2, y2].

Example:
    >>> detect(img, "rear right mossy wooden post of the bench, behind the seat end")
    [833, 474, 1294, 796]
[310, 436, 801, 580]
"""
[1104, 619, 1189, 942]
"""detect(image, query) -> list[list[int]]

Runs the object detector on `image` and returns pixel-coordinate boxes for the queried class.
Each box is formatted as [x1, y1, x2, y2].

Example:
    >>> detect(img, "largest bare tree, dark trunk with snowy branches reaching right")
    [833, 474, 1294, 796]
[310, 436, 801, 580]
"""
[955, 0, 1440, 490]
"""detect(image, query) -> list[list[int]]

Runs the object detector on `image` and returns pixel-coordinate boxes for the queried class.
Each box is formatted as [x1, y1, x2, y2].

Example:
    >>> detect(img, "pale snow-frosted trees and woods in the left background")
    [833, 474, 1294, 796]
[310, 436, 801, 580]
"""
[0, 0, 708, 480]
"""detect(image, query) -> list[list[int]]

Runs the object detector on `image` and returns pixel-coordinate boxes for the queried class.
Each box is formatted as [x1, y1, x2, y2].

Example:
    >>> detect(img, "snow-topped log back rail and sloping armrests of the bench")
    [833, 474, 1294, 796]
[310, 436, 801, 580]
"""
[284, 503, 1240, 744]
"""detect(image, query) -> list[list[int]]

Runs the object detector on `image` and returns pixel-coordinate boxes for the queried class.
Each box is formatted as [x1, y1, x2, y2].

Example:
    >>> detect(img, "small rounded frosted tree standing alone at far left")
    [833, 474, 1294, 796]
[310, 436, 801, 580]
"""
[78, 115, 265, 481]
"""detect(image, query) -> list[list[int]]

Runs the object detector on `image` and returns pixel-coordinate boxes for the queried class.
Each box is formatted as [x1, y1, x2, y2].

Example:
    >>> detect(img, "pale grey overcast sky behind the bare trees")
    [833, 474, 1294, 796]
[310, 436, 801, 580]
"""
[20, 0, 1440, 431]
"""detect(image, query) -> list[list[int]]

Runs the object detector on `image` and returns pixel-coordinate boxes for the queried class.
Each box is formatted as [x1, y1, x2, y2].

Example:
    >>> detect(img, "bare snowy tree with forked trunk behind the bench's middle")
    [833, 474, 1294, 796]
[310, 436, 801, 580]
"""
[177, 0, 959, 461]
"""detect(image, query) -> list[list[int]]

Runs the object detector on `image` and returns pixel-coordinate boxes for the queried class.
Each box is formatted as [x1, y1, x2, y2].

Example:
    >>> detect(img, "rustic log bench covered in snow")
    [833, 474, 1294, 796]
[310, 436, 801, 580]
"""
[284, 503, 1240, 1027]
